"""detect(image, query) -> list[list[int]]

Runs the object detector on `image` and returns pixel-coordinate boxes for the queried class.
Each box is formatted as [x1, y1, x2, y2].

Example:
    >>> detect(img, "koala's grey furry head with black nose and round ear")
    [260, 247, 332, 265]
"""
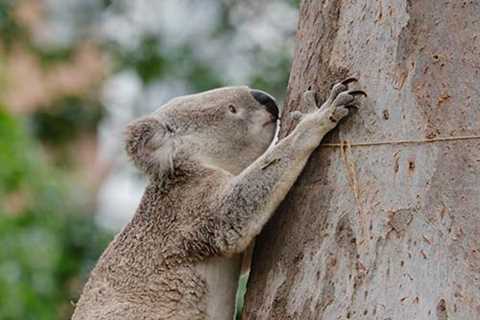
[126, 86, 279, 176]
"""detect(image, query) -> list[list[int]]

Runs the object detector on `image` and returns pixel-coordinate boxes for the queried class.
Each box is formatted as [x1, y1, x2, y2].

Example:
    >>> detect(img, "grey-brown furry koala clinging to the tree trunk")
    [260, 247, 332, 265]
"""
[72, 78, 365, 320]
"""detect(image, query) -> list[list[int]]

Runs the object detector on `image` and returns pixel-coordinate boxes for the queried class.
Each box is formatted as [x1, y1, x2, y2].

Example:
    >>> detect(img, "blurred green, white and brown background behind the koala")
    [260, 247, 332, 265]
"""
[0, 0, 298, 320]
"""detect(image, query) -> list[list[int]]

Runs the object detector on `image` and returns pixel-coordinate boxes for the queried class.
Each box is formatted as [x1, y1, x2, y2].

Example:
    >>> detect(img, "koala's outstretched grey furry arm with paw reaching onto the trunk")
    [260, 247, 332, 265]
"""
[212, 79, 364, 255]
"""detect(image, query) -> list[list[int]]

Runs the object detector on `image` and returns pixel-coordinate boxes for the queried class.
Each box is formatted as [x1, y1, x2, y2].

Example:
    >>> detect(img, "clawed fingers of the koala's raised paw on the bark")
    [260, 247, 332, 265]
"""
[318, 78, 367, 125]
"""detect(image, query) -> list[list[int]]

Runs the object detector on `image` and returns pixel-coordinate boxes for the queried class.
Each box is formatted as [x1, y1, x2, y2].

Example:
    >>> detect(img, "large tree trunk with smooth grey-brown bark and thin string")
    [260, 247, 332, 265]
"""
[243, 0, 480, 320]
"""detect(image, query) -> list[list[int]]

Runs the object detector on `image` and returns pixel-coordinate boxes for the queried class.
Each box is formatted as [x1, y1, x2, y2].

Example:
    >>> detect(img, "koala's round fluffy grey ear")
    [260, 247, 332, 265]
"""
[125, 117, 175, 176]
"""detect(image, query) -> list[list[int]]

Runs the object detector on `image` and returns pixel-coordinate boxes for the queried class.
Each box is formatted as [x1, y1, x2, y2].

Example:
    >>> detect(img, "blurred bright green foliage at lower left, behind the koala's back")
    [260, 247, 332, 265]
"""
[0, 109, 111, 320]
